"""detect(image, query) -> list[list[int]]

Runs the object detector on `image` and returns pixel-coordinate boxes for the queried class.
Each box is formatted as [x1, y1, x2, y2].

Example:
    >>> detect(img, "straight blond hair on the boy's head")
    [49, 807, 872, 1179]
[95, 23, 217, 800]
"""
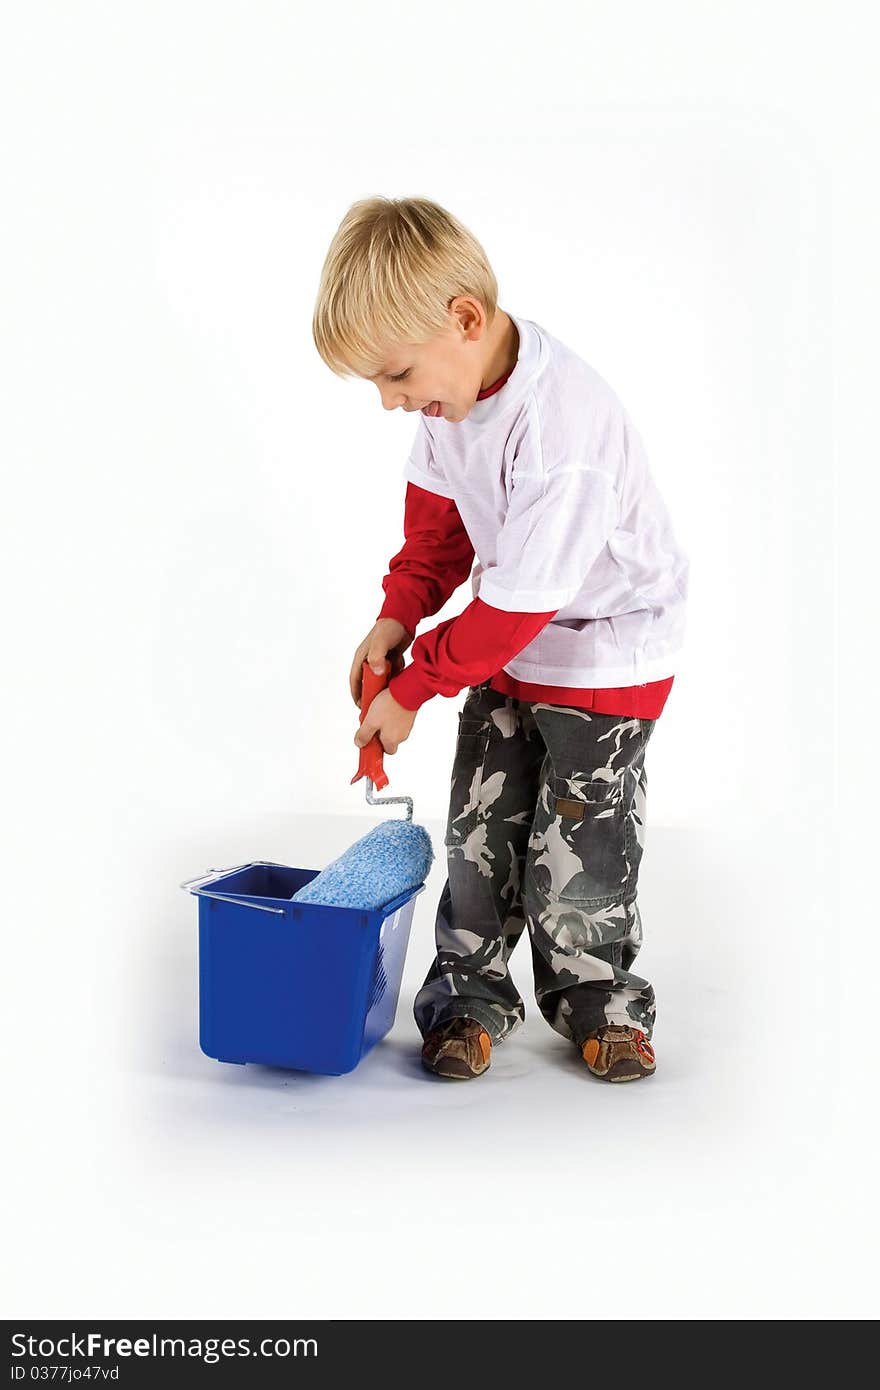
[311, 197, 498, 378]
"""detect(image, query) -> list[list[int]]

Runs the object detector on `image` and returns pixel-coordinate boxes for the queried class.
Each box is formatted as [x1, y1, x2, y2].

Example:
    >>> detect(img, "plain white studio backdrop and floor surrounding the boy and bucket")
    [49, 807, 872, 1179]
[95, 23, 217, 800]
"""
[0, 0, 877, 1319]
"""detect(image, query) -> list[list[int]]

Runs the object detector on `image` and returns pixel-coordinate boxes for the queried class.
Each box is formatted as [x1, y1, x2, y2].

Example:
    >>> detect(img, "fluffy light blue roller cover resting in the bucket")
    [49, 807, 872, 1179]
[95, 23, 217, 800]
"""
[291, 820, 434, 910]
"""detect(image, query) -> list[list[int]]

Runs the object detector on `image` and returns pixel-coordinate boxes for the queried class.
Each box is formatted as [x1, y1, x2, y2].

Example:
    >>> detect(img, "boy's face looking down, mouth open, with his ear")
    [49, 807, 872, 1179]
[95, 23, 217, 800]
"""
[370, 304, 487, 421]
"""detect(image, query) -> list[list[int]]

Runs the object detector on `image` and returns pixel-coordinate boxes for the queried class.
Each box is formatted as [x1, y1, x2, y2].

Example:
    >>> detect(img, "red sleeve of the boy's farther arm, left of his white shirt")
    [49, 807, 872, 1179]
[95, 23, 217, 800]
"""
[378, 482, 474, 636]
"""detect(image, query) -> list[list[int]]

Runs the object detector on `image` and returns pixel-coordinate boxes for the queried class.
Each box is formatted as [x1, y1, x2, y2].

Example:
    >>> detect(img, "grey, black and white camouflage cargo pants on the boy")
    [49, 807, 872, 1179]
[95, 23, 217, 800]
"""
[413, 682, 656, 1047]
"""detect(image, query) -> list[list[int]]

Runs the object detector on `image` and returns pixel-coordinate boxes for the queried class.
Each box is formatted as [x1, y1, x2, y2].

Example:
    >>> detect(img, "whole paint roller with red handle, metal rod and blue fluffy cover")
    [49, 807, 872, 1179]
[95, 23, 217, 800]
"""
[291, 660, 434, 910]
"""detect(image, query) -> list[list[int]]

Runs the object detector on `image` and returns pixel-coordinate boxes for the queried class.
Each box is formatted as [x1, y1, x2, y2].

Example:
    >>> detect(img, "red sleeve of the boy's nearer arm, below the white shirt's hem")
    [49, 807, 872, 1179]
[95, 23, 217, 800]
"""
[388, 598, 559, 710]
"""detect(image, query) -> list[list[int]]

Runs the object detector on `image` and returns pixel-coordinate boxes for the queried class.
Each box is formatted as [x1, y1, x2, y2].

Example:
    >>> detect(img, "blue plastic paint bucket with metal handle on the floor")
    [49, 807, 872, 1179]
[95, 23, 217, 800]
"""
[181, 859, 425, 1076]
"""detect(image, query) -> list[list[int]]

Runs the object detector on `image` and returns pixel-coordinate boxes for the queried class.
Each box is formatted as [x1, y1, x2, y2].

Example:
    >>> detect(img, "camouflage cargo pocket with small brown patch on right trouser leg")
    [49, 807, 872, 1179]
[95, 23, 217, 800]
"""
[532, 770, 630, 910]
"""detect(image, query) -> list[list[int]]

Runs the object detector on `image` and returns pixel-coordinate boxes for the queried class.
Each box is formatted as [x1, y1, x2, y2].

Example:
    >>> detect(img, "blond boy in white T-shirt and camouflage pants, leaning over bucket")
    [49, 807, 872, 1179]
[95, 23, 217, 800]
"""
[313, 197, 688, 1081]
